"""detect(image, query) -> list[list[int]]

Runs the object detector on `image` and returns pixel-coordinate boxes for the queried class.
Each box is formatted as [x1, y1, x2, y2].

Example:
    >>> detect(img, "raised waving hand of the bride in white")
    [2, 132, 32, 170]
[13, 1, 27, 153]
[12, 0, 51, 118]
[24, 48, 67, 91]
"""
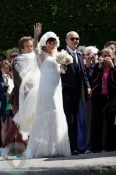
[34, 22, 42, 38]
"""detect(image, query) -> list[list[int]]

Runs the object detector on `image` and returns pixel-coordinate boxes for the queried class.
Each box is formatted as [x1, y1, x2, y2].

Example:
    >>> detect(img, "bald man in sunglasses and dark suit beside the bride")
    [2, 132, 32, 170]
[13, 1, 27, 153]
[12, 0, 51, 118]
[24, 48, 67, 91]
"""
[61, 31, 91, 154]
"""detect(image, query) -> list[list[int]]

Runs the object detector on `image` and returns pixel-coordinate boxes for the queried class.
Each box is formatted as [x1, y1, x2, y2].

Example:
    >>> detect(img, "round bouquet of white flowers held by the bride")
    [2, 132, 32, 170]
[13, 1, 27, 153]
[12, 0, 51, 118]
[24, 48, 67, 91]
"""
[56, 50, 73, 66]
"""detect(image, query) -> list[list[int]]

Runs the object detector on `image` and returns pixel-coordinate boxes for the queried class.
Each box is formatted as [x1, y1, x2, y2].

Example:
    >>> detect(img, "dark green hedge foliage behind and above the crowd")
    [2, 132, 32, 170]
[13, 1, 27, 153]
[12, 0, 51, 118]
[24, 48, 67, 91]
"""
[0, 0, 116, 49]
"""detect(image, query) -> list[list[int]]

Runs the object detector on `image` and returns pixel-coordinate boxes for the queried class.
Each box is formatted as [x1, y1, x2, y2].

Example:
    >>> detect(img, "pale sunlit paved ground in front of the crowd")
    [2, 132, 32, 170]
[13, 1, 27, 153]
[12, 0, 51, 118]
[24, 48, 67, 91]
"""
[0, 152, 116, 175]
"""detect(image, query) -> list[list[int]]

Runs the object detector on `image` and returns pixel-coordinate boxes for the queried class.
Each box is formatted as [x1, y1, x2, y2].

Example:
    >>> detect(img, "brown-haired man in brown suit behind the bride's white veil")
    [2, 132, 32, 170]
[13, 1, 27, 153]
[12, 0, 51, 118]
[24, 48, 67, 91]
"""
[3, 36, 33, 151]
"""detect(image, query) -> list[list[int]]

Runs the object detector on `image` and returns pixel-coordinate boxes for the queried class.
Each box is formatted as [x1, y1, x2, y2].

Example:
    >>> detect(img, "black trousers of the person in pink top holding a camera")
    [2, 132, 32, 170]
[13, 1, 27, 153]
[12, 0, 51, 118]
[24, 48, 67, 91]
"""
[91, 94, 110, 152]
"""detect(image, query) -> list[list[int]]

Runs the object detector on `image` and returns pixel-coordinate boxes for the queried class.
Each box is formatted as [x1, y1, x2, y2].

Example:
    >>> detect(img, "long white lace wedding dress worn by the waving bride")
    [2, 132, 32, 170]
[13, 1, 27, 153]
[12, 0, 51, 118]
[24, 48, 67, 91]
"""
[25, 54, 71, 158]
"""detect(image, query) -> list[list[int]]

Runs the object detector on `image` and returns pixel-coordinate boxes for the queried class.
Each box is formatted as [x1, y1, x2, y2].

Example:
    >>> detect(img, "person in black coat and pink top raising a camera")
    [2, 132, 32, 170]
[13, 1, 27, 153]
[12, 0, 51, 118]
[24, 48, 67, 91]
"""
[91, 48, 116, 152]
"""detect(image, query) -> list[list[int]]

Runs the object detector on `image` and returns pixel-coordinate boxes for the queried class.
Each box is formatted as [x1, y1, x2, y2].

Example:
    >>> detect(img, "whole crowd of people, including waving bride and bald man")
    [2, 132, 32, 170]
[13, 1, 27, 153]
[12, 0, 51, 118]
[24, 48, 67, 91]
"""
[0, 23, 116, 158]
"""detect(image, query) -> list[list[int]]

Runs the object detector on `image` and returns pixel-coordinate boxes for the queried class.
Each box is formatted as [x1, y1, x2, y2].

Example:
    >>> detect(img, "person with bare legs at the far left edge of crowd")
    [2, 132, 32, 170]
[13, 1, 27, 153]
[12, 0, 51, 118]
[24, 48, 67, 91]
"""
[0, 60, 14, 145]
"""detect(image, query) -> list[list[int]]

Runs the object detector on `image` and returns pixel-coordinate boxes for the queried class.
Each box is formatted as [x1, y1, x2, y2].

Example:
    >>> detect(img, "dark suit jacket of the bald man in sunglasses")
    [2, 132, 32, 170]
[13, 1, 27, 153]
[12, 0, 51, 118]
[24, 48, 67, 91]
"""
[61, 47, 90, 101]
